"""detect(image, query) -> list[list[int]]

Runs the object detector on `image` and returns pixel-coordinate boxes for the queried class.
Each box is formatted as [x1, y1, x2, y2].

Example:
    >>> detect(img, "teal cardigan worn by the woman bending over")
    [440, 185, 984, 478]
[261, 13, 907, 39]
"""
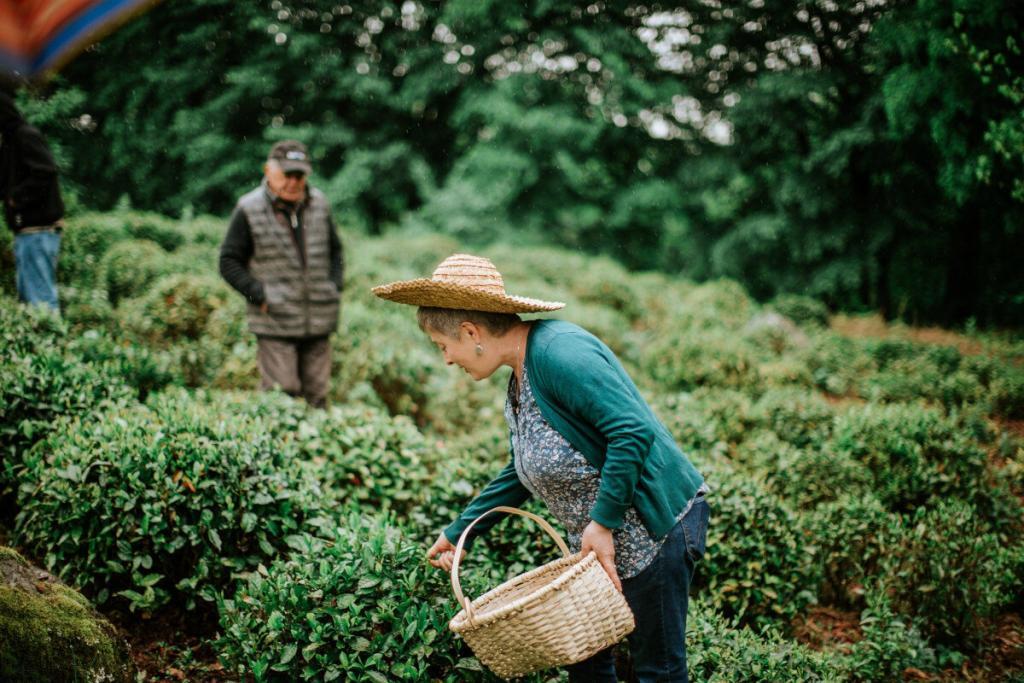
[444, 321, 703, 545]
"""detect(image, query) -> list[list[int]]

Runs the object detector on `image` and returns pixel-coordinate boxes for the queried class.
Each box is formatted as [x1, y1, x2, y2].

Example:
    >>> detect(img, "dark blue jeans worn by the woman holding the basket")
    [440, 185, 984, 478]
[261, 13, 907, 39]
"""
[566, 497, 711, 683]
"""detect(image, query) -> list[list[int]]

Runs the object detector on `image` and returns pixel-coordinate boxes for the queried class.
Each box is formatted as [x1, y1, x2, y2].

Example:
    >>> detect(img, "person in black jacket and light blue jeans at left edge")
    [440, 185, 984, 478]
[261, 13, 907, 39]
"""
[0, 89, 65, 311]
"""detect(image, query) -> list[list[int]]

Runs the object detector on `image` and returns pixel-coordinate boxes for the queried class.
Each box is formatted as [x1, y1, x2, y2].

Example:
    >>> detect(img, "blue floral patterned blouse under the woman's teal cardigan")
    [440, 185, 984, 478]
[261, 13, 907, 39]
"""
[505, 366, 707, 579]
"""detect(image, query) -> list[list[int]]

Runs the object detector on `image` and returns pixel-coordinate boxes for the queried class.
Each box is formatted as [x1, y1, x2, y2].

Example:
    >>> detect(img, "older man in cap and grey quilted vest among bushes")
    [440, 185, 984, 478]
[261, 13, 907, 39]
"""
[220, 140, 344, 408]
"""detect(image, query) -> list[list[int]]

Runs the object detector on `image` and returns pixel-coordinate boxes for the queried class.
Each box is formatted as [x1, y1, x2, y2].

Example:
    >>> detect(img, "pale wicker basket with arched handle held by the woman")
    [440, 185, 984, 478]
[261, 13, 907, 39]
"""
[449, 507, 635, 678]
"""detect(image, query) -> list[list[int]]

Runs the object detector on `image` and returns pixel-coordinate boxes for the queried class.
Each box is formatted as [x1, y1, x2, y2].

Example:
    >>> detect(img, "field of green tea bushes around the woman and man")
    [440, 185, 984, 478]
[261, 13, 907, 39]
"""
[0, 211, 1024, 683]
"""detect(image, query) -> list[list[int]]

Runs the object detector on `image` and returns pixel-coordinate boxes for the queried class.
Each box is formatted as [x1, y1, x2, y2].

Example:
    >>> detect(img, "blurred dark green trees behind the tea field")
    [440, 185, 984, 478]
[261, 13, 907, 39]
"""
[8, 0, 1024, 327]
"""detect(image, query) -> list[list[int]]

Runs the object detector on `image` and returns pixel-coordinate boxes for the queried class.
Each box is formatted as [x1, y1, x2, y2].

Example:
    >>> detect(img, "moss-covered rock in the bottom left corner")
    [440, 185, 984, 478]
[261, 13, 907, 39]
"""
[0, 547, 135, 683]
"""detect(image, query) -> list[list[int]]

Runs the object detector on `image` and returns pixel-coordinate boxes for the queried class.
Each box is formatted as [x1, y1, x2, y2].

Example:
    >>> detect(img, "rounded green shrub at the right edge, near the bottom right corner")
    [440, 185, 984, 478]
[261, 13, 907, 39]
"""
[882, 500, 1019, 647]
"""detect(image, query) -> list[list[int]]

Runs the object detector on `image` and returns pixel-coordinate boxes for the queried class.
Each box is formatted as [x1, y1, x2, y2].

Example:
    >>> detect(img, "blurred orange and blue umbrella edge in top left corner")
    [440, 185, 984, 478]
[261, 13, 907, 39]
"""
[0, 0, 159, 80]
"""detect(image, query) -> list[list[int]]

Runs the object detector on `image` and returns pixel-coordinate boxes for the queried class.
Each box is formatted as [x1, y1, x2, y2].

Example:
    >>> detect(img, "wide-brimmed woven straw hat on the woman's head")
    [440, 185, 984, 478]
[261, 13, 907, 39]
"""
[373, 254, 565, 313]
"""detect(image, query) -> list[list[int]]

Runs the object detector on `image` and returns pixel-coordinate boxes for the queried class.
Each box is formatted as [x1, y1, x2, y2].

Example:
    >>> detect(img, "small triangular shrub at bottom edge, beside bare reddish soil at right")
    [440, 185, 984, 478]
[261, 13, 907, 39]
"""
[842, 591, 936, 683]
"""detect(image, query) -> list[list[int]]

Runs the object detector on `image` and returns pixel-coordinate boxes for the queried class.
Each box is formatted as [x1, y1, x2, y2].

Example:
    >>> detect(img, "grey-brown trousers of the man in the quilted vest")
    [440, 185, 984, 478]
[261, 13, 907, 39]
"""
[256, 337, 331, 408]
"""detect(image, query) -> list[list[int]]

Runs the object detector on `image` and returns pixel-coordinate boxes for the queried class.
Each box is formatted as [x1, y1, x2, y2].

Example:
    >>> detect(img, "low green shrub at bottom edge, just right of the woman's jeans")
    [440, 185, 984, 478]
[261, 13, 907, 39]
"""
[686, 600, 843, 683]
